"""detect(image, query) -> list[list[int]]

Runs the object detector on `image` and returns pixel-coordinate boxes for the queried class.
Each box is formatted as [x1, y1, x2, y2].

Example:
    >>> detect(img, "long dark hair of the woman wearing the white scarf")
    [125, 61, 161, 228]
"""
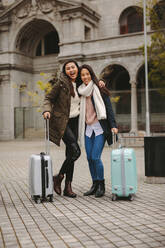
[80, 64, 110, 96]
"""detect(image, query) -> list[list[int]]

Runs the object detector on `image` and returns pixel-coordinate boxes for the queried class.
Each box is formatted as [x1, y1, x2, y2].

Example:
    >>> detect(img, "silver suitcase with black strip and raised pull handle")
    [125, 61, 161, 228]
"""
[29, 119, 53, 203]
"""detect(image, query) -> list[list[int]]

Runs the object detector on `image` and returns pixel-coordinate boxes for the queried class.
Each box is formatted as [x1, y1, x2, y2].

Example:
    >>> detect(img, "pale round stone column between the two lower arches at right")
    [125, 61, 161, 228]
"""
[130, 81, 138, 135]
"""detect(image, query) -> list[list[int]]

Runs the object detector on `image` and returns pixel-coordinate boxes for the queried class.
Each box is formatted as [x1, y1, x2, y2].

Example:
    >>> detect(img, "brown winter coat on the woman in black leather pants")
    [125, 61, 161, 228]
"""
[43, 73, 71, 146]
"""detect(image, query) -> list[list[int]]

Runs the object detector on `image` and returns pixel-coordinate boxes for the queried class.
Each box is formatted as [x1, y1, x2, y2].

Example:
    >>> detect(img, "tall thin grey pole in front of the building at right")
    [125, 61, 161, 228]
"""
[143, 0, 150, 136]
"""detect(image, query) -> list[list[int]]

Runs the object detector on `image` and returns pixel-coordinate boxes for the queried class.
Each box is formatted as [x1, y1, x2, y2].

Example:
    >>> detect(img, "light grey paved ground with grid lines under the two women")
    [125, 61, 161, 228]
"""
[0, 141, 165, 248]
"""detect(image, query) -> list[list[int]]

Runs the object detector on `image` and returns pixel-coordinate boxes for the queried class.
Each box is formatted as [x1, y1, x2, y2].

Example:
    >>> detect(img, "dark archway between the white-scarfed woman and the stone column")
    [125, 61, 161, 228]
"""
[101, 64, 131, 132]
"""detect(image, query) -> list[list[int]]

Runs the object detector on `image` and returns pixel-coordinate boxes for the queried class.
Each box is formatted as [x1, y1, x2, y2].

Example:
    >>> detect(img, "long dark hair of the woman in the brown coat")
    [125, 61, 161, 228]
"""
[62, 59, 80, 97]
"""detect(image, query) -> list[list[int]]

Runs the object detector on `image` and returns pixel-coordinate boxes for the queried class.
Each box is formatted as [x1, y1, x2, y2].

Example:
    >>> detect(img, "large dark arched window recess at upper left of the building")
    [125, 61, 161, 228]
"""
[16, 19, 59, 56]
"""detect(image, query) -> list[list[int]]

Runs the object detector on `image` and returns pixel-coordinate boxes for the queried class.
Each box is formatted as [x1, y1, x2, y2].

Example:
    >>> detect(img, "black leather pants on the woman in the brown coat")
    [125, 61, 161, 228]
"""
[59, 117, 81, 181]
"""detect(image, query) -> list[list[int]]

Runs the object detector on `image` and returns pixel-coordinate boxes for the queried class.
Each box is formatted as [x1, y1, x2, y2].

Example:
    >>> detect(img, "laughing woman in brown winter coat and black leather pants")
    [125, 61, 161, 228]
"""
[43, 59, 104, 197]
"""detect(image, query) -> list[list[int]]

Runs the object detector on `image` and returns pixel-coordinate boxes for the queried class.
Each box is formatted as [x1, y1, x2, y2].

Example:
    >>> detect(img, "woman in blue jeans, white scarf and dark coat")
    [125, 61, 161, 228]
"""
[78, 65, 118, 197]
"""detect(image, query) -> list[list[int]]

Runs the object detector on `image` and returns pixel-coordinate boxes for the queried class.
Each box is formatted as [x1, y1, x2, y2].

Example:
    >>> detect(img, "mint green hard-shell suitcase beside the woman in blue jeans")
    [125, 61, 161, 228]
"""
[111, 141, 137, 201]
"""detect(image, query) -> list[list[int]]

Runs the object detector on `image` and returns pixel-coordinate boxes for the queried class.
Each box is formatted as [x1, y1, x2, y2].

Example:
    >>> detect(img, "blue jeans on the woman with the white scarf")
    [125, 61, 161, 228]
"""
[85, 132, 105, 181]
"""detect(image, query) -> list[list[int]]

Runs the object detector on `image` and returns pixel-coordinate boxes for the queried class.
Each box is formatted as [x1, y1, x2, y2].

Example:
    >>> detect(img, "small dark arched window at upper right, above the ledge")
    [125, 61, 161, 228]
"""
[119, 7, 143, 34]
